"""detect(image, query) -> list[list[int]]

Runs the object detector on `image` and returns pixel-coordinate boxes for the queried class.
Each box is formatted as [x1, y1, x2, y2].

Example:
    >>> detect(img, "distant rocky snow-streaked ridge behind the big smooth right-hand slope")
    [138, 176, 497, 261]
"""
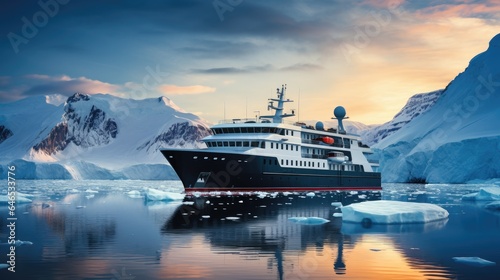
[357, 89, 444, 146]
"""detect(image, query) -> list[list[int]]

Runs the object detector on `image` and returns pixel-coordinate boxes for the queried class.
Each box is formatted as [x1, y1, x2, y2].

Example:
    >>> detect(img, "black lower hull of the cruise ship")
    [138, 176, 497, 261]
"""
[161, 149, 381, 191]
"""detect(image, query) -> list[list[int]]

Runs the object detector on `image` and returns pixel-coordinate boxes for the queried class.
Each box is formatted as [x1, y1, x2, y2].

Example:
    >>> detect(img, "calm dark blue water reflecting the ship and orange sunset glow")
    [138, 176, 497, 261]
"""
[0, 181, 500, 280]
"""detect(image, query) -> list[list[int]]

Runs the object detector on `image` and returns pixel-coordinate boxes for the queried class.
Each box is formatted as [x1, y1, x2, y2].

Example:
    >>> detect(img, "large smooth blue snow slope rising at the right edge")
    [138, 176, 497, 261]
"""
[373, 34, 500, 183]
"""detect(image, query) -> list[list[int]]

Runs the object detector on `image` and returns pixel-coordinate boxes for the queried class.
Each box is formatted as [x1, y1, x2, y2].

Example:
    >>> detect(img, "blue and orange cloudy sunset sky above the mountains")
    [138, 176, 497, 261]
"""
[0, 0, 500, 124]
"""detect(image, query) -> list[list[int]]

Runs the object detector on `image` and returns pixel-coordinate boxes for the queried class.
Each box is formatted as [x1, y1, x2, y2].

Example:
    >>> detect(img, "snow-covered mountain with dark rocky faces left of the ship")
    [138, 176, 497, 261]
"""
[0, 93, 210, 179]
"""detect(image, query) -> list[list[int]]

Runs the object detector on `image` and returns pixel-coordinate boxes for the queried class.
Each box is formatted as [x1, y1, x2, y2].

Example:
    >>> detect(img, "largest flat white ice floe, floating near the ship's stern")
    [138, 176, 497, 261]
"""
[342, 200, 449, 224]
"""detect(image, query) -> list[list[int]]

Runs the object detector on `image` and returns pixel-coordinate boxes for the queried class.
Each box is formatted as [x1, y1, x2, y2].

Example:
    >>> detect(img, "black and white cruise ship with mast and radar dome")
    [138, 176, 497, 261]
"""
[161, 85, 381, 192]
